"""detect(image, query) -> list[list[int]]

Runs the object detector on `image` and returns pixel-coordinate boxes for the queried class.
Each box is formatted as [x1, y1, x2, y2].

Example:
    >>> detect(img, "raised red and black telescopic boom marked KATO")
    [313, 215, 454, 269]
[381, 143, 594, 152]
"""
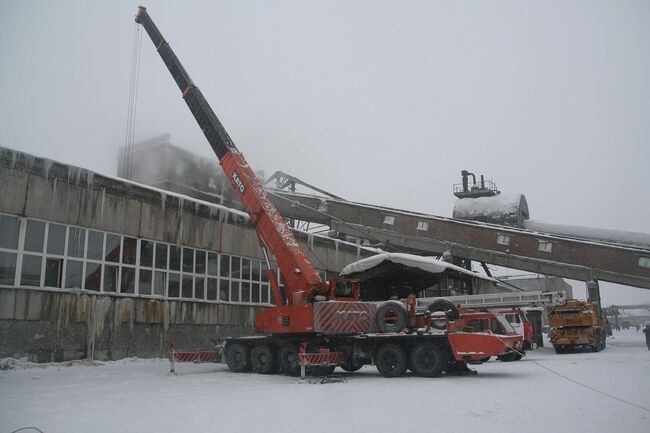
[135, 6, 328, 305]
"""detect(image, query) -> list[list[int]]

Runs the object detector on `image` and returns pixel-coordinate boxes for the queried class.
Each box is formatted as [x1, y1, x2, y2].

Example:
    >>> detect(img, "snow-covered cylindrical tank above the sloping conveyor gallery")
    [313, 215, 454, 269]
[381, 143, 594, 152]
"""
[453, 194, 530, 227]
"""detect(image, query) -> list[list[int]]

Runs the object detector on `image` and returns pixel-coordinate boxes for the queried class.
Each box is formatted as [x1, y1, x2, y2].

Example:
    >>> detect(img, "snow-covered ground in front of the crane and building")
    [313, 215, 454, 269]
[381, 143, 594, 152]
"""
[0, 329, 650, 433]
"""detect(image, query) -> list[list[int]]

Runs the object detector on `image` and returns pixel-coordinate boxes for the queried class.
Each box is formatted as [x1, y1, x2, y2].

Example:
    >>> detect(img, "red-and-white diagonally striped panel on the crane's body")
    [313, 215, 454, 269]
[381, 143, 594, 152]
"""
[314, 301, 377, 334]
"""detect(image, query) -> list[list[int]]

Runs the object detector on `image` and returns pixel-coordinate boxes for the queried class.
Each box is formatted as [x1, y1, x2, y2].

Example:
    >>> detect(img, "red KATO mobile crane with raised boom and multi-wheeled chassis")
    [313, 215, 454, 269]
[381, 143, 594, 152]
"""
[135, 6, 521, 377]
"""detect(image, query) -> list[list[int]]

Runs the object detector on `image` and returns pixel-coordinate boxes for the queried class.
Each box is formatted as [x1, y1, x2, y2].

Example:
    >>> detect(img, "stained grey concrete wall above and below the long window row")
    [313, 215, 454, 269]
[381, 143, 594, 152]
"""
[0, 148, 373, 361]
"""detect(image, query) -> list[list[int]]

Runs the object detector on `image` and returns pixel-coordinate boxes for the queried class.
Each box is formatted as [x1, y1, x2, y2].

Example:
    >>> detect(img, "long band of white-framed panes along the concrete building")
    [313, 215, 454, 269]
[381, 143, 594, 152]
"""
[0, 214, 270, 304]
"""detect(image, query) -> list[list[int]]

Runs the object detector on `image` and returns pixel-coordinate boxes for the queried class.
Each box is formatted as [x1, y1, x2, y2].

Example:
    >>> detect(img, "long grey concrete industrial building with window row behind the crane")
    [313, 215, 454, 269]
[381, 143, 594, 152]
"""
[0, 148, 374, 362]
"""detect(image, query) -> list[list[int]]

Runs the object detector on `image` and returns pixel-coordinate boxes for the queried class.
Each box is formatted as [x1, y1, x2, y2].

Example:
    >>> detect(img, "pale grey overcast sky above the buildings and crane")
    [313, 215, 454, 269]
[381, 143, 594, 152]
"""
[0, 0, 650, 304]
